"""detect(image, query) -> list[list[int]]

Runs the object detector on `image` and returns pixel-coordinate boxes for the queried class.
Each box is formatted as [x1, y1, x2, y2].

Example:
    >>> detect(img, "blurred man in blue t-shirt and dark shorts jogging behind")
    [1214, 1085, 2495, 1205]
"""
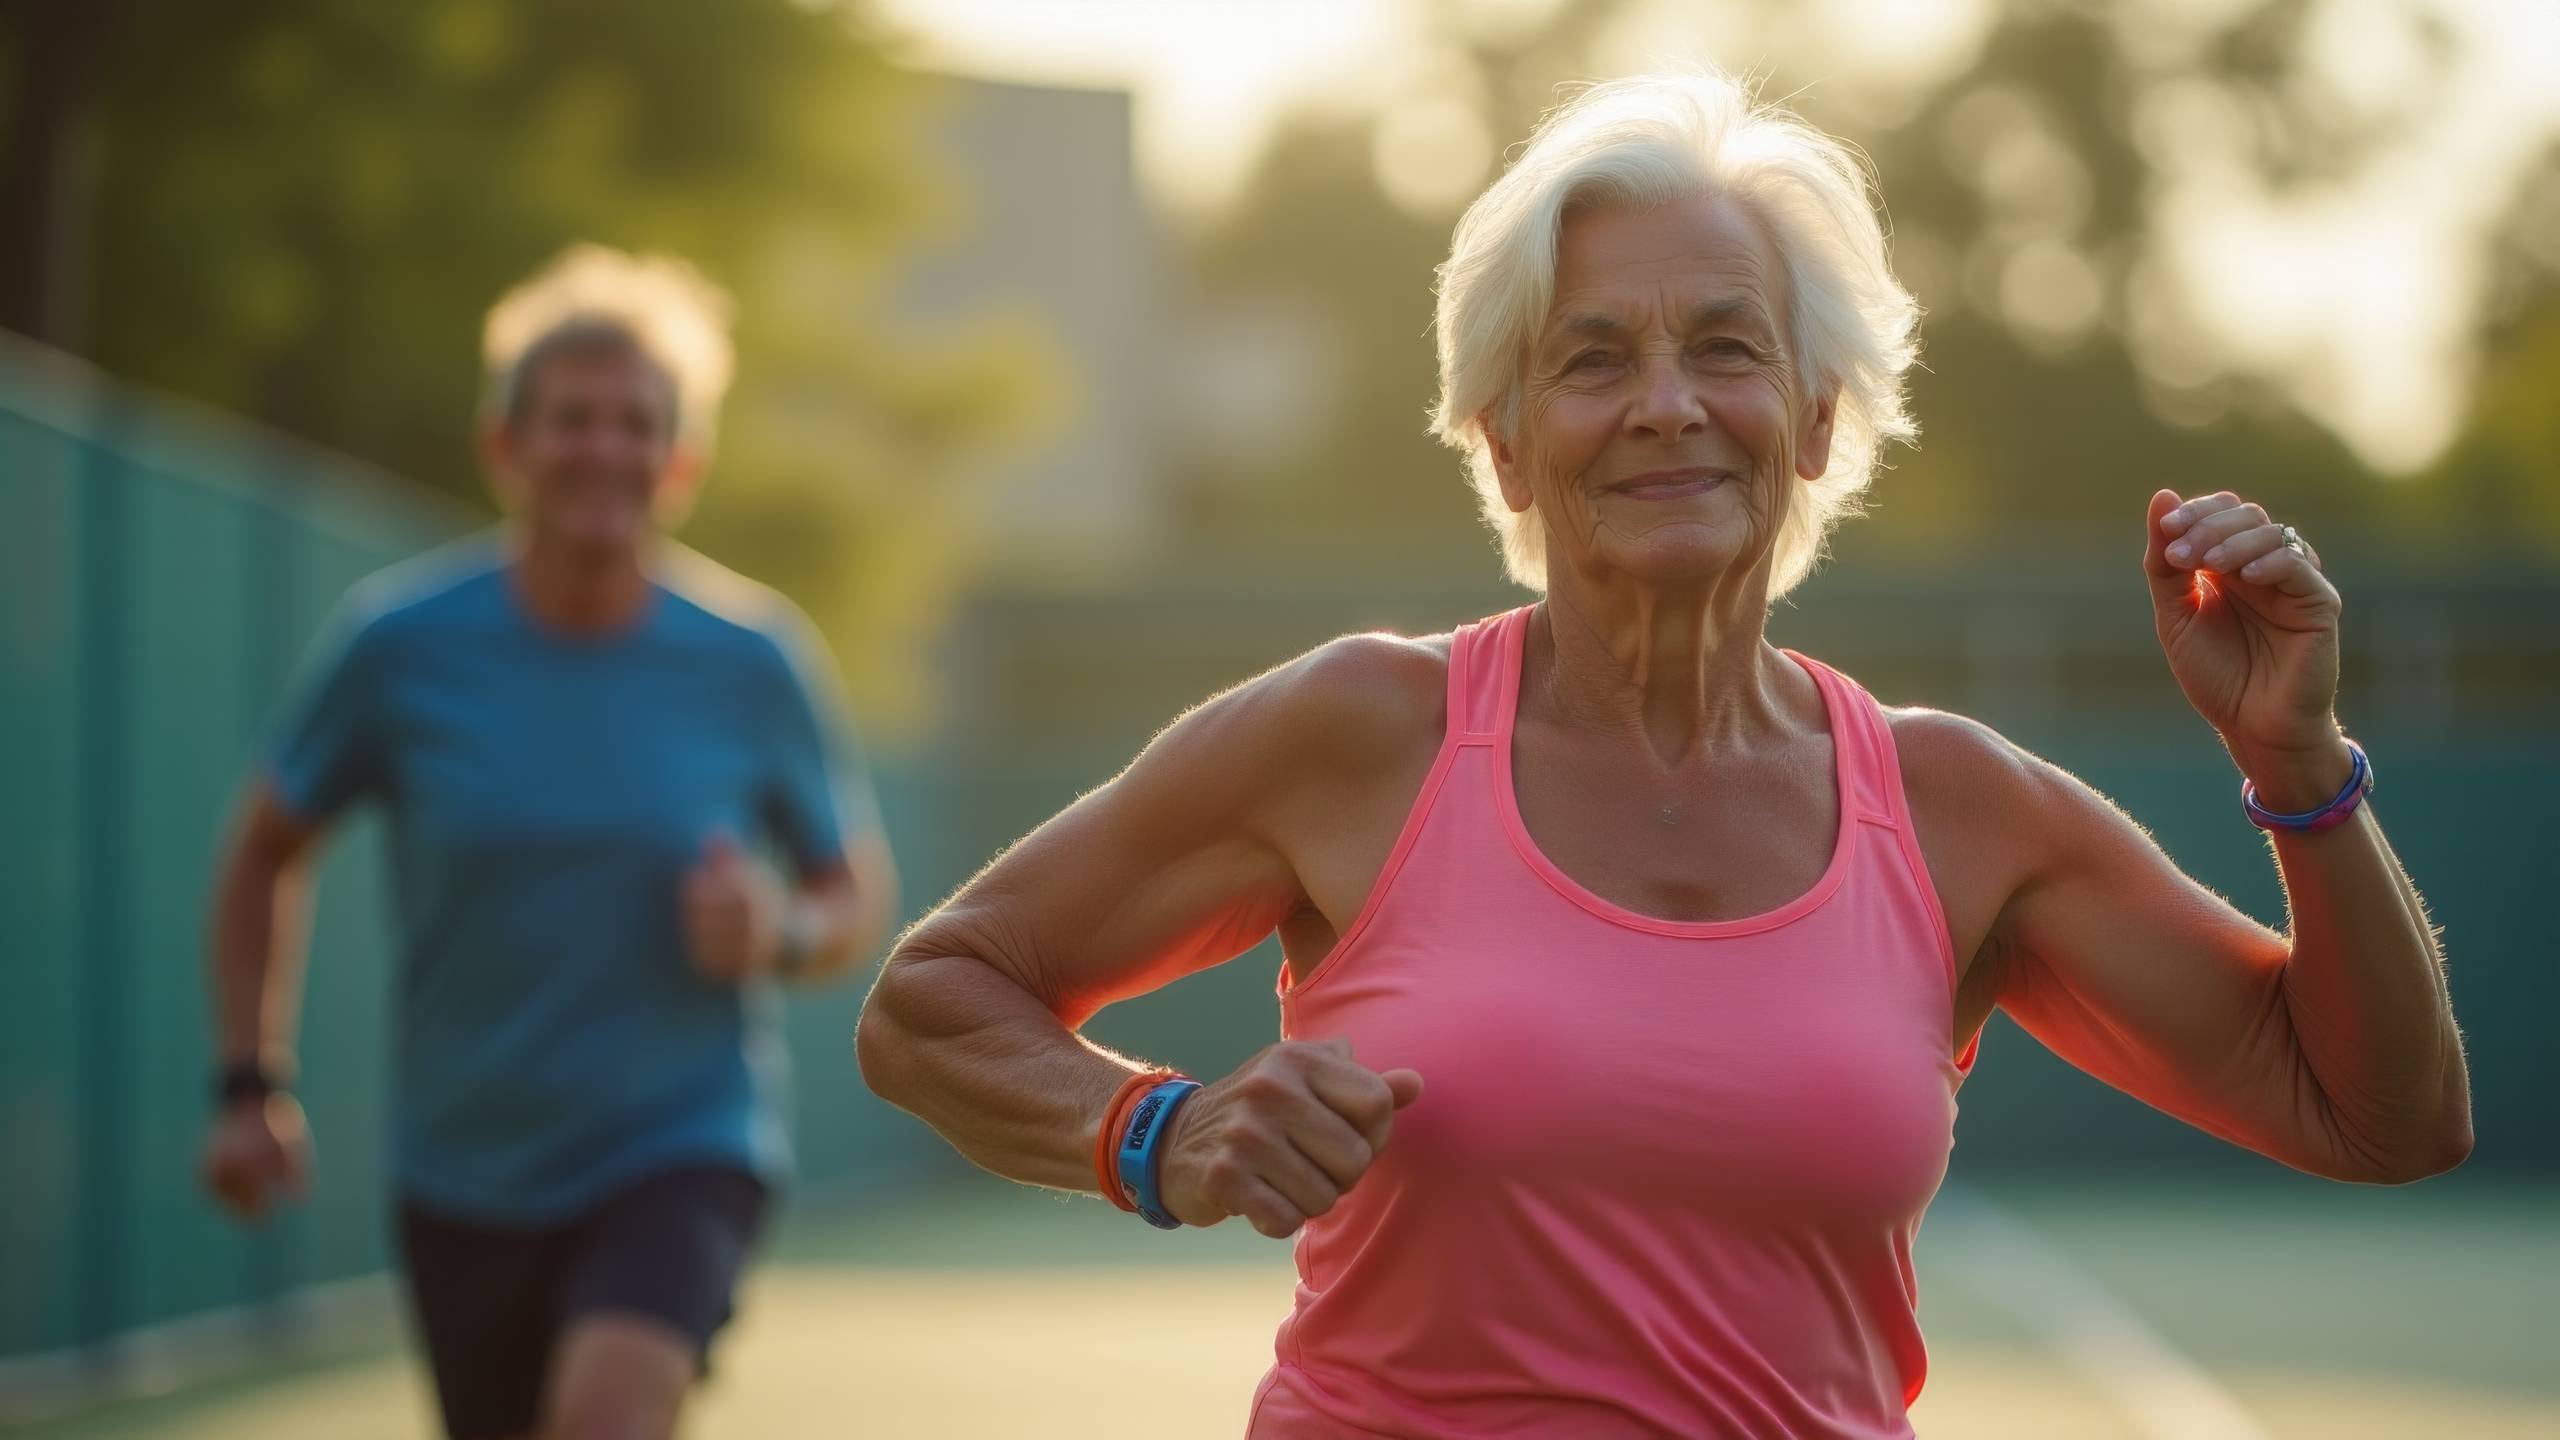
[205, 249, 896, 1437]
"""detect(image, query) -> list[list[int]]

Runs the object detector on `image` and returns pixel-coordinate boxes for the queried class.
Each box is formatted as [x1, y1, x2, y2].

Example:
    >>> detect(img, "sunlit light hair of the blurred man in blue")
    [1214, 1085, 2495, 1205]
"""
[481, 243, 735, 454]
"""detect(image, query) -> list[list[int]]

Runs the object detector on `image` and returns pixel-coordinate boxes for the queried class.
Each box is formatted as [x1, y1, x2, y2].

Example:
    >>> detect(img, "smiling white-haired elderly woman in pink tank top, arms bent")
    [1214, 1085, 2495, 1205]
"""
[860, 77, 2470, 1437]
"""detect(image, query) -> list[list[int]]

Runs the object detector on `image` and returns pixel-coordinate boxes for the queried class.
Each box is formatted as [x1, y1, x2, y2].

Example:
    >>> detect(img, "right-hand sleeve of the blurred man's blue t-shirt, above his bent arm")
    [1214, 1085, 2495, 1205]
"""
[763, 609, 881, 871]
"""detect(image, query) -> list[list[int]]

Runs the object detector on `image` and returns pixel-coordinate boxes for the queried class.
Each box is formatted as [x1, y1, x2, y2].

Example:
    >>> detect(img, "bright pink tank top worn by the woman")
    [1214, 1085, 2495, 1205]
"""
[1249, 607, 1974, 1440]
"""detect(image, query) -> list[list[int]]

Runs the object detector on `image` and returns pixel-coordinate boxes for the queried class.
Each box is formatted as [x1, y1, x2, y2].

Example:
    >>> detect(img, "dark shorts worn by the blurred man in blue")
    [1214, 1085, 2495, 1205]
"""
[399, 1166, 765, 1440]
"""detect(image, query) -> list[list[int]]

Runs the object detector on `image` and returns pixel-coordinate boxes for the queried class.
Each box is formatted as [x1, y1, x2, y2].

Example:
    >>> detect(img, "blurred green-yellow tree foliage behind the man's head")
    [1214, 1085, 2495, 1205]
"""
[0, 0, 1050, 723]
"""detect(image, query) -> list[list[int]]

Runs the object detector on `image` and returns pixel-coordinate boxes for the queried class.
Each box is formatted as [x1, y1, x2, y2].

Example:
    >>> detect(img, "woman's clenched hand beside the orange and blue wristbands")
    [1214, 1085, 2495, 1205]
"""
[1162, 1040, 1423, 1240]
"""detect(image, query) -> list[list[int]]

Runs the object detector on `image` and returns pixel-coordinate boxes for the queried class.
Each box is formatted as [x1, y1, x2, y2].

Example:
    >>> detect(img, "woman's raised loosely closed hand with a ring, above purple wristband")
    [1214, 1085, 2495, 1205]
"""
[2143, 489, 2345, 789]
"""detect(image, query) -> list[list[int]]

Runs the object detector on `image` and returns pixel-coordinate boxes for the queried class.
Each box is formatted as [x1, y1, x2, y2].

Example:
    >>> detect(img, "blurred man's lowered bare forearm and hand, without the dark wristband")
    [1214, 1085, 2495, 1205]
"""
[202, 781, 323, 1220]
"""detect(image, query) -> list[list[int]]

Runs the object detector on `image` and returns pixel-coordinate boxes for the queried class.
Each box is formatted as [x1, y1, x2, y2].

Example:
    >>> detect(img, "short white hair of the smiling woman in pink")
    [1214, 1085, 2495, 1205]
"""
[1431, 74, 1920, 600]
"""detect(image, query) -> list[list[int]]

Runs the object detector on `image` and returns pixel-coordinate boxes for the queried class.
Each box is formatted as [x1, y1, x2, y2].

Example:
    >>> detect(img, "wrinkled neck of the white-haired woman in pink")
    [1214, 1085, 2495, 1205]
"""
[1531, 566, 1787, 769]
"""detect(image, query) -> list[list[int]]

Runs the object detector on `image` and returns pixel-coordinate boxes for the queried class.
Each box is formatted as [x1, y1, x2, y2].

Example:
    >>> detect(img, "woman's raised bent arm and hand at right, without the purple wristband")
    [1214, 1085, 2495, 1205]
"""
[1925, 489, 2470, 1184]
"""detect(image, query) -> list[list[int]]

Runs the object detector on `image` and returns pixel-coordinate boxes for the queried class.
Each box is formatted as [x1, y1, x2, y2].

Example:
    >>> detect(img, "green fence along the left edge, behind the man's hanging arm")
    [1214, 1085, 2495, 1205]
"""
[0, 333, 456, 1353]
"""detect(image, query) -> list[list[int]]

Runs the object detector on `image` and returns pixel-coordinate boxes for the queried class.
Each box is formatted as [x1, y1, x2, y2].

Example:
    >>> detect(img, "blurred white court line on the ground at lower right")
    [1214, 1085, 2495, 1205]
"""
[1925, 1181, 2271, 1440]
